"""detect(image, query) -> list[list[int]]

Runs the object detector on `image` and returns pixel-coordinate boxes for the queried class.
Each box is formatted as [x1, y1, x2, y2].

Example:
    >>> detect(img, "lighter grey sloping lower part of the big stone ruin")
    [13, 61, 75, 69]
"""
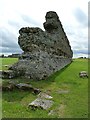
[9, 51, 71, 80]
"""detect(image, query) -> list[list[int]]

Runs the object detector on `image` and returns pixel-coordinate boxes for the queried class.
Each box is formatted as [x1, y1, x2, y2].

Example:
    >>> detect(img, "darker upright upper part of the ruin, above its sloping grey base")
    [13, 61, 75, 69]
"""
[18, 11, 72, 58]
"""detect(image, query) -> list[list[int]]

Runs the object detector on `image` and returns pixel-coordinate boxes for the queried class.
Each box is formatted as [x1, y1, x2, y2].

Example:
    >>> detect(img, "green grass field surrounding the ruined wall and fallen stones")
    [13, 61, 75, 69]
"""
[0, 58, 88, 118]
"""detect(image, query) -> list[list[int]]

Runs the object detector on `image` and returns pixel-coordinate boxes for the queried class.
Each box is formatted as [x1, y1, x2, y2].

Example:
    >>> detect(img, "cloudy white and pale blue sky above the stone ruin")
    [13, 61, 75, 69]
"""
[0, 0, 89, 57]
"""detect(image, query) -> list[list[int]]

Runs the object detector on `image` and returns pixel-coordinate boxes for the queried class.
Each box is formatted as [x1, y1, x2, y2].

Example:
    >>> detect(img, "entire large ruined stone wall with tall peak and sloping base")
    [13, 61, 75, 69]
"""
[9, 11, 73, 80]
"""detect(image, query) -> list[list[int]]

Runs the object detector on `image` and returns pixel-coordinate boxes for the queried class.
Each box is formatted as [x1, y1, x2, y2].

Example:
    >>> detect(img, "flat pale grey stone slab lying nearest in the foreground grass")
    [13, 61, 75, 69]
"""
[29, 98, 53, 110]
